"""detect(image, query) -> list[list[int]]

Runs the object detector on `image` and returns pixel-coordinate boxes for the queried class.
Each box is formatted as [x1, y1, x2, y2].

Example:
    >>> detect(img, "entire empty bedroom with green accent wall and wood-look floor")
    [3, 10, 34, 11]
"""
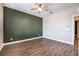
[0, 3, 79, 56]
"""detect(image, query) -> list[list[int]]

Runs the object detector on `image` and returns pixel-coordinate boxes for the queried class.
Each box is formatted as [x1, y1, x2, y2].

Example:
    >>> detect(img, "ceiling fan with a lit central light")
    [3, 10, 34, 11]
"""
[31, 3, 52, 13]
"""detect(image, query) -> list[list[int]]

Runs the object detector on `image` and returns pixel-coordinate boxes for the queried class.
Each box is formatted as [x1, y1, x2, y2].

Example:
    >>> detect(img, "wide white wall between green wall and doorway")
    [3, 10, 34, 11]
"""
[43, 7, 78, 44]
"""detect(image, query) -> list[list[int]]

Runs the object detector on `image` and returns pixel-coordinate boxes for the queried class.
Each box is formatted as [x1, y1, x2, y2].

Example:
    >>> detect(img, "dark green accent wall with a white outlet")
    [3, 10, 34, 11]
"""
[4, 7, 42, 43]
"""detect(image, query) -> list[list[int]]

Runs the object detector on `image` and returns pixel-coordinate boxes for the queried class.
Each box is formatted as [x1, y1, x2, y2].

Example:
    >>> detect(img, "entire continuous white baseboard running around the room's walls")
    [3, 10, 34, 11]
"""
[0, 36, 73, 50]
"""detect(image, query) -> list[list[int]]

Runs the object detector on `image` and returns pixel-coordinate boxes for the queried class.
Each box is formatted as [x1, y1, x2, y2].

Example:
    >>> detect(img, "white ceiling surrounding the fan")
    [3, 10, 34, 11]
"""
[3, 3, 79, 17]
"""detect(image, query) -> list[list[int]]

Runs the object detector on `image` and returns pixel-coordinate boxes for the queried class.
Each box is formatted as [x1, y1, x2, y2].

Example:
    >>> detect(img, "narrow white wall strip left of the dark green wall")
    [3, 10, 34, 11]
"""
[0, 4, 3, 50]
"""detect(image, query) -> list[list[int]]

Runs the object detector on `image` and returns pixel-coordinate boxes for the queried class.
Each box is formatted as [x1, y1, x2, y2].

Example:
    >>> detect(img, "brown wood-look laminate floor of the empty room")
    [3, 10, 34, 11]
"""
[0, 38, 78, 56]
